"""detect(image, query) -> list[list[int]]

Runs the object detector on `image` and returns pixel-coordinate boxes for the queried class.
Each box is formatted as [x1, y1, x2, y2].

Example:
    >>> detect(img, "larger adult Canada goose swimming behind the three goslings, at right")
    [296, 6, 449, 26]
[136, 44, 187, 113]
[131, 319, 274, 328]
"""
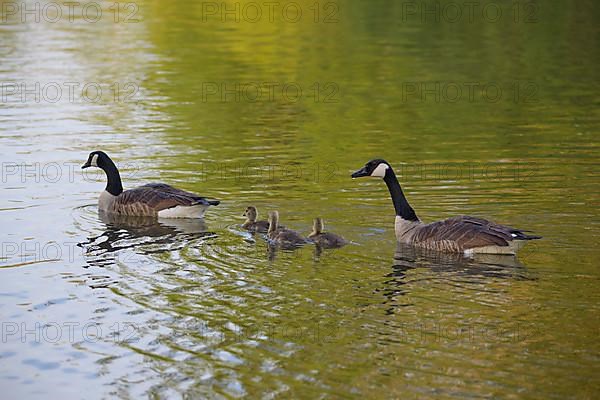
[352, 159, 541, 254]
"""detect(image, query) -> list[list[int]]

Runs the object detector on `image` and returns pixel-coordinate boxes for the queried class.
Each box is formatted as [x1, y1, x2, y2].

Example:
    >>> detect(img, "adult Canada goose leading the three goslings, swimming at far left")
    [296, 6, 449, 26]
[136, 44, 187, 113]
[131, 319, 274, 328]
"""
[81, 151, 219, 218]
